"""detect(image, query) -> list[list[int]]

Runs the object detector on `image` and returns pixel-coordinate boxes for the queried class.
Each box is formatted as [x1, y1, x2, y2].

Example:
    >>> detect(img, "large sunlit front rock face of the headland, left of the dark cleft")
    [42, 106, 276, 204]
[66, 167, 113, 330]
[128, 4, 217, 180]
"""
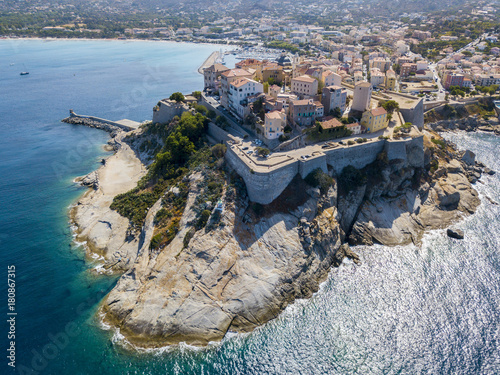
[102, 175, 346, 347]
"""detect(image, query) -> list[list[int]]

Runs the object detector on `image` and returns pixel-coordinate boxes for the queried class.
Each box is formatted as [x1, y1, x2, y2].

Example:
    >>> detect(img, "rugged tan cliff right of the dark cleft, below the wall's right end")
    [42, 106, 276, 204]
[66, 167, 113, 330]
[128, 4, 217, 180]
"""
[345, 132, 484, 246]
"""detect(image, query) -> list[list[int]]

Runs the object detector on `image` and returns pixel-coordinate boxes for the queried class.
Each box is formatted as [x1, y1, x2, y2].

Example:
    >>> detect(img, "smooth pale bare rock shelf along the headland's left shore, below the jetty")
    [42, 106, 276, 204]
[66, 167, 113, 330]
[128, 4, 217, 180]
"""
[70, 132, 146, 269]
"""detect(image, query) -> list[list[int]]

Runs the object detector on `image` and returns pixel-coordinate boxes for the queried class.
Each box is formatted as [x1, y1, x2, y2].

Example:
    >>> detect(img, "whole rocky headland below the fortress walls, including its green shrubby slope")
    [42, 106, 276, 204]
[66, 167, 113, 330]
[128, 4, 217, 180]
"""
[68, 104, 484, 347]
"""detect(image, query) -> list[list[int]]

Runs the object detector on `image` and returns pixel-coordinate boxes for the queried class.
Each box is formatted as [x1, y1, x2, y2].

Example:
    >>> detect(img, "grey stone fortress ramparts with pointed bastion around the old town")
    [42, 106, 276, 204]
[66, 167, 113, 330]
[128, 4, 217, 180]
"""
[161, 95, 424, 204]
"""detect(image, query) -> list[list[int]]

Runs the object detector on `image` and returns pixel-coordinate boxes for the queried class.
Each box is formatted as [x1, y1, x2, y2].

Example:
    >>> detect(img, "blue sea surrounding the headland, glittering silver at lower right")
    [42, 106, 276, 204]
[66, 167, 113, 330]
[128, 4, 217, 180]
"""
[0, 40, 500, 375]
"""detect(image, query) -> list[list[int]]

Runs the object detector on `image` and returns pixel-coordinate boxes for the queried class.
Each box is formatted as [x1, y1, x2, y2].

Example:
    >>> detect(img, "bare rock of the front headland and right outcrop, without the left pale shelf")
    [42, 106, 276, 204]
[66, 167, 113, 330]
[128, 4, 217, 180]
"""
[96, 129, 488, 347]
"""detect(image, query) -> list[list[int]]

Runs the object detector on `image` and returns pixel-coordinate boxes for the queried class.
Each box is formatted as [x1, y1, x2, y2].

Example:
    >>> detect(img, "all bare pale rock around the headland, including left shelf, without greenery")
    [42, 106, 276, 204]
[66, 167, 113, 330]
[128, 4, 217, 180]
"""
[67, 116, 494, 348]
